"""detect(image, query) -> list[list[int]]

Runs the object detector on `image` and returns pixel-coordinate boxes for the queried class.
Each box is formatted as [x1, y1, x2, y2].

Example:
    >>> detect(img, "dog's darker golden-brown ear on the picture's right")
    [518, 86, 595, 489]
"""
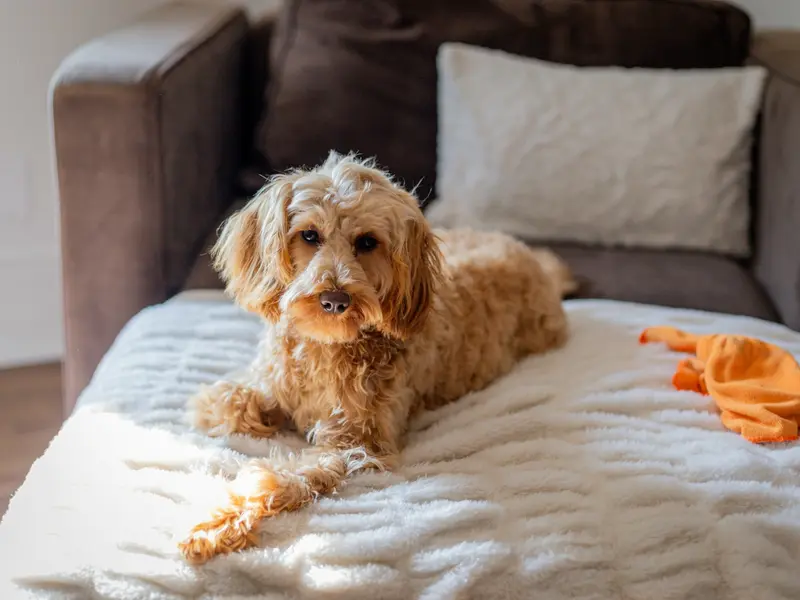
[380, 209, 442, 339]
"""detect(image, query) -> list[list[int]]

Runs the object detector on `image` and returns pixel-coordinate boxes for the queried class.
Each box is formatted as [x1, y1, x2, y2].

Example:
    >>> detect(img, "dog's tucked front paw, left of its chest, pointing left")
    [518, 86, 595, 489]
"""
[190, 381, 286, 437]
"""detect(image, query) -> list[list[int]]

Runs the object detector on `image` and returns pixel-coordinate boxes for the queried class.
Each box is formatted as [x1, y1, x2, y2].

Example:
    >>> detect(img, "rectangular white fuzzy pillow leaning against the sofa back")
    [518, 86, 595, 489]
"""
[427, 44, 766, 256]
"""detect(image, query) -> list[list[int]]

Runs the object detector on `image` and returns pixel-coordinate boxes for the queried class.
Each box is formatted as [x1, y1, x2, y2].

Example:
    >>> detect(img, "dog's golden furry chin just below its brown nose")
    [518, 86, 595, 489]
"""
[289, 296, 380, 344]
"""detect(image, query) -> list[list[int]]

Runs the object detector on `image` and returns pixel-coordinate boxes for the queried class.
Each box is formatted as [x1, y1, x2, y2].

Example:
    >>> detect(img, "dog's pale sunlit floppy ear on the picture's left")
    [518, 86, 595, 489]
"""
[211, 175, 293, 321]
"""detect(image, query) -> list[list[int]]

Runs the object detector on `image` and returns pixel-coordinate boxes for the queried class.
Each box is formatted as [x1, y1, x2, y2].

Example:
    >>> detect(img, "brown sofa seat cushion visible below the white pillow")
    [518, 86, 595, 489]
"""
[551, 244, 779, 321]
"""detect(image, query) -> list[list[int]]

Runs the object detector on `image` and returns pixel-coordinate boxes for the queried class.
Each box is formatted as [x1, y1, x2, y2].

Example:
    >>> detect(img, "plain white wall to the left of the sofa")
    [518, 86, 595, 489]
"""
[0, 0, 166, 365]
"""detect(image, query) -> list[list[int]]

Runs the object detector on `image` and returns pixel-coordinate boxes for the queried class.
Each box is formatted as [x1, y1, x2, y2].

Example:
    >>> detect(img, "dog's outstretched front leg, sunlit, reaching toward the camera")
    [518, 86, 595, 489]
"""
[179, 449, 382, 564]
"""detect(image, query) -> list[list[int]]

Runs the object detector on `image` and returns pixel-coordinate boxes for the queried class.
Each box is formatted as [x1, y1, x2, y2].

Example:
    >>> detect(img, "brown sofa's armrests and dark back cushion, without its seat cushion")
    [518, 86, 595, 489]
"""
[52, 0, 800, 412]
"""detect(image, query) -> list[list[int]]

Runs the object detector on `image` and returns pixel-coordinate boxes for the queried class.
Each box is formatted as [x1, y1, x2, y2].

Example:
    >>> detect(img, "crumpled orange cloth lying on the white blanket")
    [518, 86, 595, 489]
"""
[639, 327, 800, 443]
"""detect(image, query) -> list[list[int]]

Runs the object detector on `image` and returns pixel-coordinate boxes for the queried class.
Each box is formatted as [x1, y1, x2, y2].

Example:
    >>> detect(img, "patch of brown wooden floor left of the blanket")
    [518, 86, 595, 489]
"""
[0, 364, 61, 515]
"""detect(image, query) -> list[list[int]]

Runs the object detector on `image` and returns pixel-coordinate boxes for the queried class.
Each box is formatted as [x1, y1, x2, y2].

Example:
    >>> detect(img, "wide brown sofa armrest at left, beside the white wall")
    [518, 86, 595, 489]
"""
[50, 3, 248, 413]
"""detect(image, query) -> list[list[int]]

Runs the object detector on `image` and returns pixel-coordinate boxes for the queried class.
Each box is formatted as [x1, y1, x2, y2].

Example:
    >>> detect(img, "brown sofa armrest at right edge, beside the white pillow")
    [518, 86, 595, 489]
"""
[752, 31, 800, 330]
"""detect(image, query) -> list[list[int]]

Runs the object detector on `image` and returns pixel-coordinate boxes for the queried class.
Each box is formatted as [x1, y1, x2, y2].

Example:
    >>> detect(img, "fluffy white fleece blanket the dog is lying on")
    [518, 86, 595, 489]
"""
[0, 294, 800, 600]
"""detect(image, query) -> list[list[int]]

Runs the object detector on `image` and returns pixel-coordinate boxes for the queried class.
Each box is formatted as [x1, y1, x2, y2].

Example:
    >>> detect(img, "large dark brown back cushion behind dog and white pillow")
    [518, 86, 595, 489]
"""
[257, 0, 750, 200]
